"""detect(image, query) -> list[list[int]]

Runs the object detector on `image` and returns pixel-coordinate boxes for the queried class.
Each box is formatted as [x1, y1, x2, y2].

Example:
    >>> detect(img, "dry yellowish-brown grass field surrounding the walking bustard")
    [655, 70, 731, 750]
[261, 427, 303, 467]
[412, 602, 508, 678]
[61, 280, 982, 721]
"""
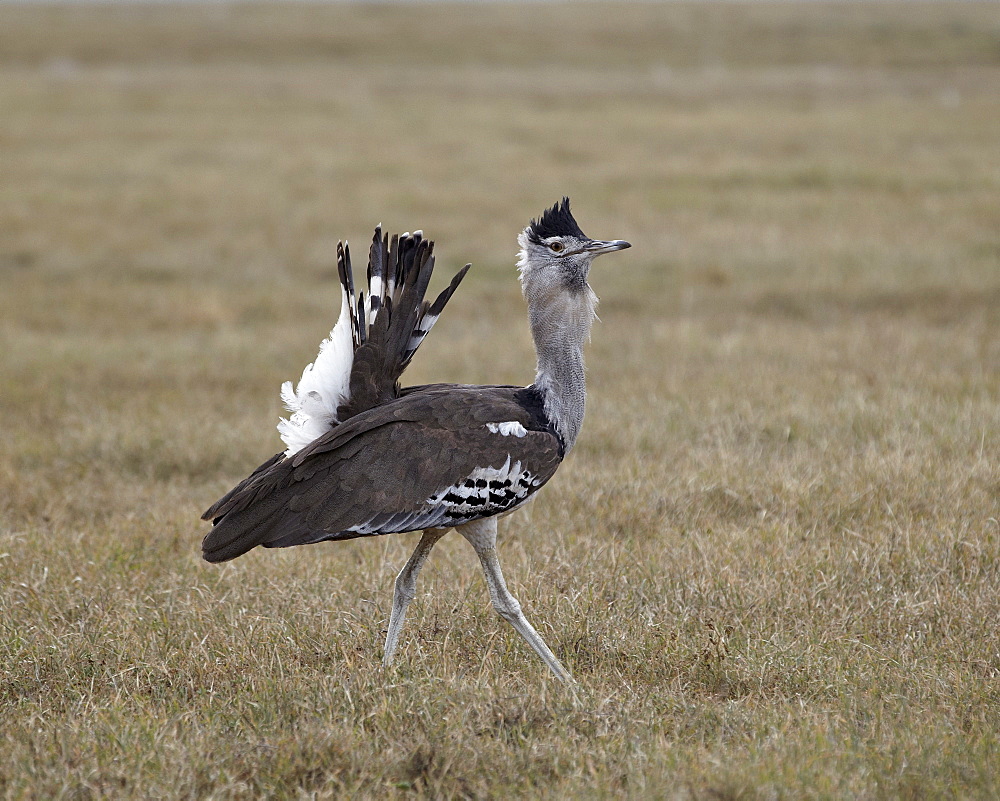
[0, 2, 1000, 799]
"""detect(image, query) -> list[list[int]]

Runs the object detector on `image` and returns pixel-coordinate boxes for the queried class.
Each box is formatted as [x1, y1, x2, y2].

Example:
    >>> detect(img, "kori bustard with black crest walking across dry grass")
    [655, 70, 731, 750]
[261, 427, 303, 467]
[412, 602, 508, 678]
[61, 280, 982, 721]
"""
[202, 198, 630, 682]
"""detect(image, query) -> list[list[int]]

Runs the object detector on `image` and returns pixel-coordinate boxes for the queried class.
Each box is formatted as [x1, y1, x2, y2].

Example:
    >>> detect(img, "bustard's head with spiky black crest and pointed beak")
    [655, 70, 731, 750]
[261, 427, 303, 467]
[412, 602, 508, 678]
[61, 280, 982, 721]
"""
[517, 197, 631, 297]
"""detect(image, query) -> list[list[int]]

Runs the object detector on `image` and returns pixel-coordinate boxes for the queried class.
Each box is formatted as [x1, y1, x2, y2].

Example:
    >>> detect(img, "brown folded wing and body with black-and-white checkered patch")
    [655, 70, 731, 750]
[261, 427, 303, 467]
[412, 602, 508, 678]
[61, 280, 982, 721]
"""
[202, 386, 563, 561]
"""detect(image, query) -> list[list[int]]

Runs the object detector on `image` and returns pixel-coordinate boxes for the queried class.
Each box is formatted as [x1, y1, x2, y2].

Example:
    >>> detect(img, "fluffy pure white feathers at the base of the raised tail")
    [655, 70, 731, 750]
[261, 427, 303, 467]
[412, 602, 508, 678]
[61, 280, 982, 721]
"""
[278, 289, 354, 456]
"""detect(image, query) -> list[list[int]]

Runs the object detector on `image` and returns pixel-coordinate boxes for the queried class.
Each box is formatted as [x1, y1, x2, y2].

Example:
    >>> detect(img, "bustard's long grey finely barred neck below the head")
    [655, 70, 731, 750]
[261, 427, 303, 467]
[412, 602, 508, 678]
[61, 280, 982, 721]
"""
[528, 286, 597, 453]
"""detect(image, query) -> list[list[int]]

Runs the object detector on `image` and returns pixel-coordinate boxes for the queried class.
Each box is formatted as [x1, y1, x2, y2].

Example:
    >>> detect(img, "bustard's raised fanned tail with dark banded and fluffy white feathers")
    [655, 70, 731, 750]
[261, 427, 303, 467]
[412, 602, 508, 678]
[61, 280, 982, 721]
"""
[278, 226, 471, 457]
